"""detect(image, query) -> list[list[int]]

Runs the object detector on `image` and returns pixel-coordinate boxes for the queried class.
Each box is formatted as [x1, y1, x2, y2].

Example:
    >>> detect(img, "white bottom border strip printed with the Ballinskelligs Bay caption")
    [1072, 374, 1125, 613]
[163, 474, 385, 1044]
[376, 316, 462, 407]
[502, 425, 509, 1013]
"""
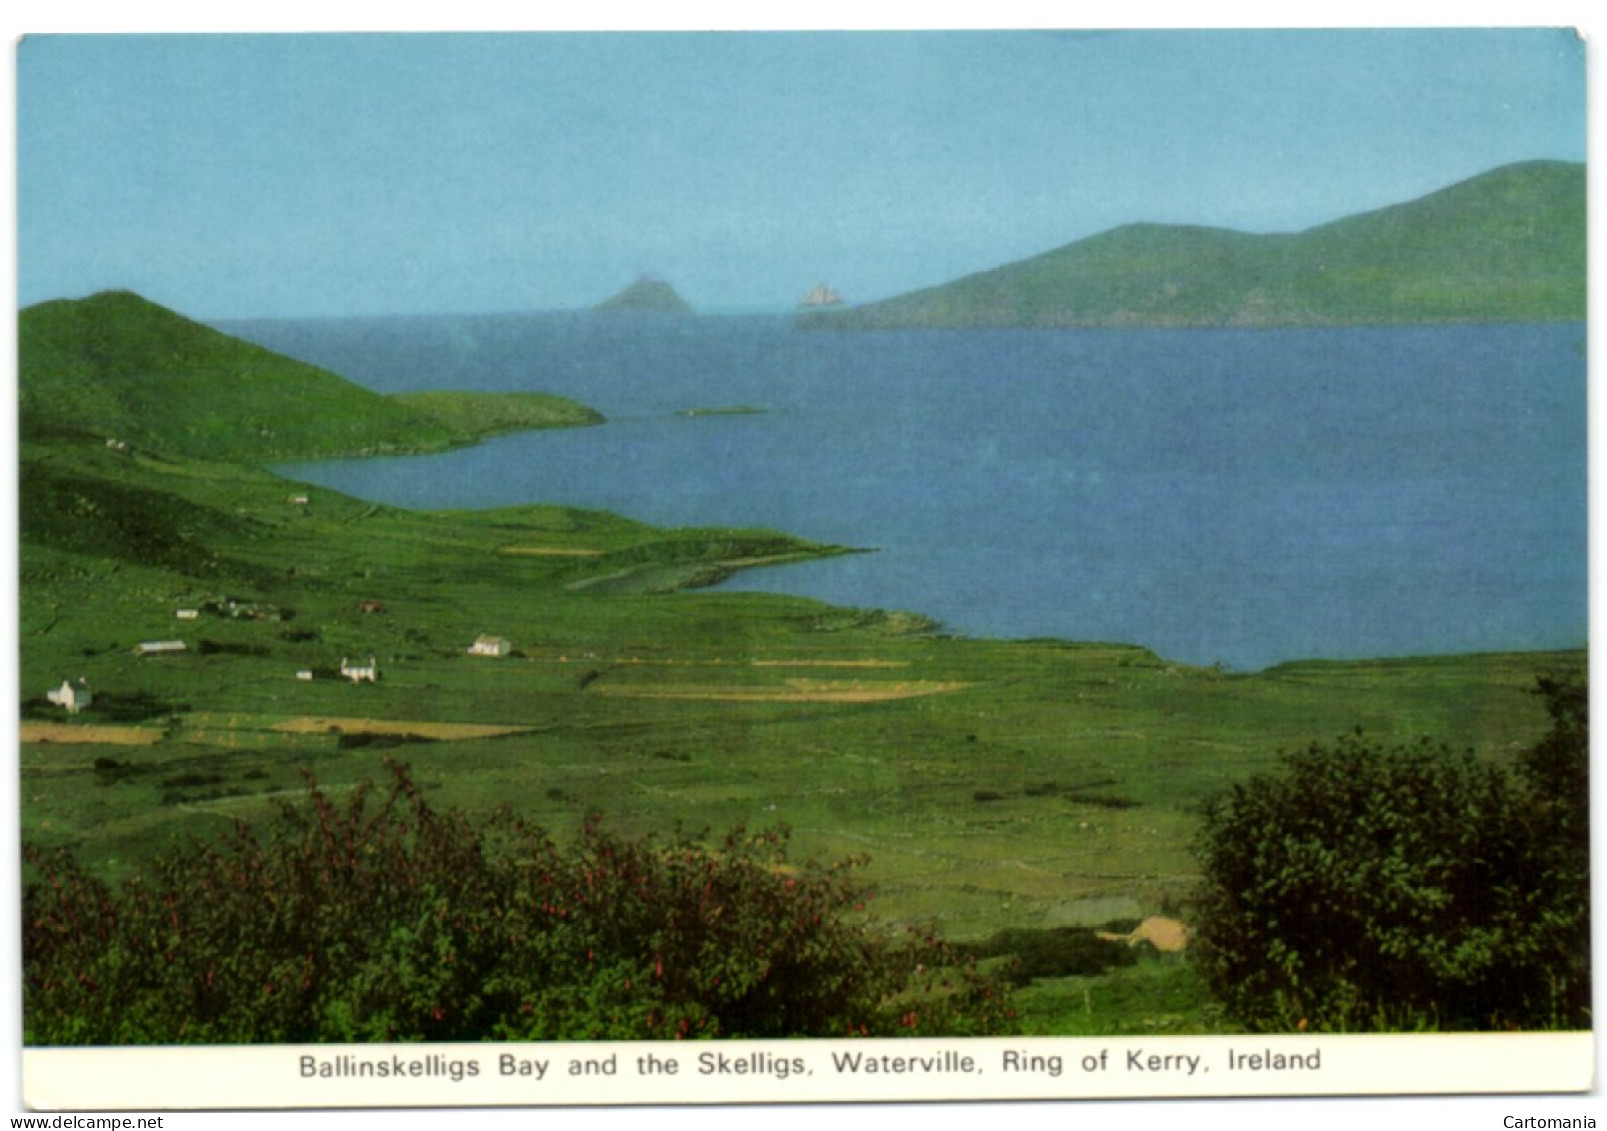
[22, 1031, 1596, 1112]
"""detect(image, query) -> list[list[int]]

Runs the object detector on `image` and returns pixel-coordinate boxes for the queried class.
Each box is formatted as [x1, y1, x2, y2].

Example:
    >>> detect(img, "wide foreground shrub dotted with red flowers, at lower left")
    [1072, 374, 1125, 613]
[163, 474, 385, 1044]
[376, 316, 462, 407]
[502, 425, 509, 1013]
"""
[22, 768, 1009, 1044]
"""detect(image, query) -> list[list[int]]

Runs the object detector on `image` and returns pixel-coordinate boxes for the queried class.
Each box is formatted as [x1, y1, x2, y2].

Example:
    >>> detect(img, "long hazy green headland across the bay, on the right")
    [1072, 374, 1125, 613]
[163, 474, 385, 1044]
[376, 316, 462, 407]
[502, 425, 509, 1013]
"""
[799, 161, 1585, 329]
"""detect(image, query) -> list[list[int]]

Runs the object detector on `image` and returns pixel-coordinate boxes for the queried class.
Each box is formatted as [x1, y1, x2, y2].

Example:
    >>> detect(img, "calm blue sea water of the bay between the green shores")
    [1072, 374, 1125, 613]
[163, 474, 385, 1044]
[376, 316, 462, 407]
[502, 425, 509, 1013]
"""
[233, 315, 1588, 668]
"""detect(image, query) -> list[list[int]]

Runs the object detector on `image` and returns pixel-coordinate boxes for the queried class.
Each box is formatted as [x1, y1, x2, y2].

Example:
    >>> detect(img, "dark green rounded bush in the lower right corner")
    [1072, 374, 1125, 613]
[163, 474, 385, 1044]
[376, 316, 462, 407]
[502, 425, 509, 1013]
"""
[1194, 691, 1589, 1031]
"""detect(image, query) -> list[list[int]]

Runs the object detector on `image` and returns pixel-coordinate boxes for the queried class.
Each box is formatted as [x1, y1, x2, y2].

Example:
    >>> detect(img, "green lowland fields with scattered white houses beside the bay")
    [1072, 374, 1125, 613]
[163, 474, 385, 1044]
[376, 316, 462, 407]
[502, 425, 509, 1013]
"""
[19, 292, 1585, 1031]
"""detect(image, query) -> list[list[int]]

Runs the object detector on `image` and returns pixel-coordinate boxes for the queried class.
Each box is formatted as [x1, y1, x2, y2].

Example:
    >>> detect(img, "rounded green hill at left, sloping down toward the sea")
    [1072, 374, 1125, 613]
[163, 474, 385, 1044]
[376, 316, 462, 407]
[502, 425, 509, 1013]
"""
[18, 291, 464, 463]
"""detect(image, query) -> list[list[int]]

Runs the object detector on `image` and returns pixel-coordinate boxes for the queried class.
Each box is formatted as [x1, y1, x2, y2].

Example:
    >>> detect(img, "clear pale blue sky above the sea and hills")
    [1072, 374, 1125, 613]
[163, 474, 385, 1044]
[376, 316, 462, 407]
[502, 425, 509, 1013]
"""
[18, 29, 1586, 318]
